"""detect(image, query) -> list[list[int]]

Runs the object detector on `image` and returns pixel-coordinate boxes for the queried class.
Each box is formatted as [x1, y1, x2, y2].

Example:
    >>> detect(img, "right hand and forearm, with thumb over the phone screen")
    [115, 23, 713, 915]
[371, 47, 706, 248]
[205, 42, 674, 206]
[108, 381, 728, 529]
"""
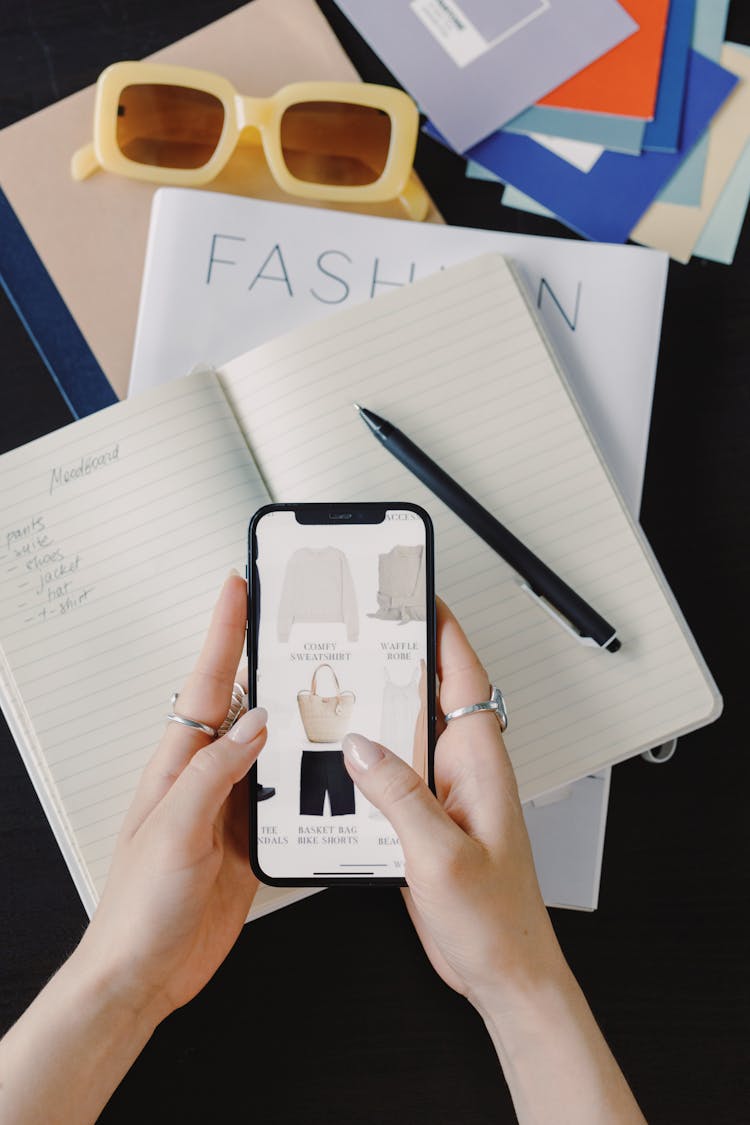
[343, 602, 644, 1125]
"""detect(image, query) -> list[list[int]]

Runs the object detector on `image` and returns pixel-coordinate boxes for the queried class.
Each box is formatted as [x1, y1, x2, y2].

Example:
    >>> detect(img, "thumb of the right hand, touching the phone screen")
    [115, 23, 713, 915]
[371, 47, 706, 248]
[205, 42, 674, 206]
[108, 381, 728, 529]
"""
[341, 734, 463, 861]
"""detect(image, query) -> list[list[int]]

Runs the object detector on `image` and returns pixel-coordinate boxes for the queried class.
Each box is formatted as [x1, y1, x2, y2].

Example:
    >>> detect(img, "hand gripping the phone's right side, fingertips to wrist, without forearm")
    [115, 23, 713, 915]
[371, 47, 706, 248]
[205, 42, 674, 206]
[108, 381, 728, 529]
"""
[343, 602, 562, 1009]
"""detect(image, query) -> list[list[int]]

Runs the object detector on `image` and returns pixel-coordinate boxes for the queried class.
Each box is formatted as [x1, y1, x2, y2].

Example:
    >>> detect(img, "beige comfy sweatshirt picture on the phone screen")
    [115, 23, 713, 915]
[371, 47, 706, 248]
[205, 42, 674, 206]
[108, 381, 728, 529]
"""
[278, 547, 360, 641]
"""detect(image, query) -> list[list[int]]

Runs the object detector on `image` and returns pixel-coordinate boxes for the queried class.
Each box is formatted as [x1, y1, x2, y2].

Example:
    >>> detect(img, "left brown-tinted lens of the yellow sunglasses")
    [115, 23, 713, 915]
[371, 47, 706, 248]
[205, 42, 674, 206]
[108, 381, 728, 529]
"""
[117, 83, 224, 169]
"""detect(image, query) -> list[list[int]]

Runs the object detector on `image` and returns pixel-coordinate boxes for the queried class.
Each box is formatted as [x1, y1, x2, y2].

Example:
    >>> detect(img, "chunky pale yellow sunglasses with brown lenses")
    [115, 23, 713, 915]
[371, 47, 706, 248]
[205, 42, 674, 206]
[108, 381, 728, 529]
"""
[71, 62, 430, 219]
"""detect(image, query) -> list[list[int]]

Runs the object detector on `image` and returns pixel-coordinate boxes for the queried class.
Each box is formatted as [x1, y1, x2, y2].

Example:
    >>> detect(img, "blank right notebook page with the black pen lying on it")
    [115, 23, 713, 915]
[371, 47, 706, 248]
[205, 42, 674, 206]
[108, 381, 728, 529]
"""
[218, 254, 720, 800]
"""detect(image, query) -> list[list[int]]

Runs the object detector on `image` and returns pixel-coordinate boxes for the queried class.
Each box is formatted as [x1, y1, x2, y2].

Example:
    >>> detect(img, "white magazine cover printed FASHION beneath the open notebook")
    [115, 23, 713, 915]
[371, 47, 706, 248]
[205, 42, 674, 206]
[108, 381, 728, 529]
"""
[128, 188, 669, 512]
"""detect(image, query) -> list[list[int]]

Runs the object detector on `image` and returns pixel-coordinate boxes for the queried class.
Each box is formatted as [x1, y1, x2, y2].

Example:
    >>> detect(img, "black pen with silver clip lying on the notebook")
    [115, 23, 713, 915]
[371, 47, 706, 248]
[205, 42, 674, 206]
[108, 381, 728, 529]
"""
[354, 403, 621, 653]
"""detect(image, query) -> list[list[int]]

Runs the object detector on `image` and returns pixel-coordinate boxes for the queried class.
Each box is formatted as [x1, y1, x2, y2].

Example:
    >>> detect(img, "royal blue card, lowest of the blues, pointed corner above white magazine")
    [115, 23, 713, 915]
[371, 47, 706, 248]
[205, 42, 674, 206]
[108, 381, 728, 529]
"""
[425, 51, 738, 242]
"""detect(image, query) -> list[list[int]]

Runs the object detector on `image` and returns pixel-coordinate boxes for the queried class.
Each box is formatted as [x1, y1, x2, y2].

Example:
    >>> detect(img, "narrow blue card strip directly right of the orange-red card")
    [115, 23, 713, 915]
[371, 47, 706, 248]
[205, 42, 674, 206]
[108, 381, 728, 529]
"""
[643, 0, 696, 152]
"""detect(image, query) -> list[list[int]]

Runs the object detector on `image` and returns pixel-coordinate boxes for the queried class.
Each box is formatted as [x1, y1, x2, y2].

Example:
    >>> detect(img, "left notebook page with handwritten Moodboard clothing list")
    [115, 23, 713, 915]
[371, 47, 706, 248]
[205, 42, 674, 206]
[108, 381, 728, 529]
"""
[0, 375, 273, 910]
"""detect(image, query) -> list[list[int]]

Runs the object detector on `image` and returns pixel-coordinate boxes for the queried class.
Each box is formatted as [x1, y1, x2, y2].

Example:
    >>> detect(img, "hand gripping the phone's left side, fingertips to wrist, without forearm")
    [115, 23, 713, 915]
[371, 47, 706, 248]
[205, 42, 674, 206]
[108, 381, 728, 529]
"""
[76, 575, 266, 1022]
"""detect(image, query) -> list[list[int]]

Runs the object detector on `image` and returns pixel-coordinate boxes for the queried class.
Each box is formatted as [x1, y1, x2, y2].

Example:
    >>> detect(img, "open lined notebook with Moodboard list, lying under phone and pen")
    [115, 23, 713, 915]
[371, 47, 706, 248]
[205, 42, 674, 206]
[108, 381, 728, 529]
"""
[0, 254, 721, 912]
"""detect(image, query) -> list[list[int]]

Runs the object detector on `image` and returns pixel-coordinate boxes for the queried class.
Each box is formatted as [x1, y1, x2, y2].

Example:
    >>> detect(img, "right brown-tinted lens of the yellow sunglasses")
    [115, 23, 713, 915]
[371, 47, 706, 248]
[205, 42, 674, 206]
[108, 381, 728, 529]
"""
[281, 101, 390, 187]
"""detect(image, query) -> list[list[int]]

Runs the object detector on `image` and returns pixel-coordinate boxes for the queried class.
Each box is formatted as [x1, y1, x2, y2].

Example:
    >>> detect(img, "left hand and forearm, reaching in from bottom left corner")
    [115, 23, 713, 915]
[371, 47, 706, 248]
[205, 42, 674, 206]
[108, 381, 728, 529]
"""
[0, 575, 266, 1125]
